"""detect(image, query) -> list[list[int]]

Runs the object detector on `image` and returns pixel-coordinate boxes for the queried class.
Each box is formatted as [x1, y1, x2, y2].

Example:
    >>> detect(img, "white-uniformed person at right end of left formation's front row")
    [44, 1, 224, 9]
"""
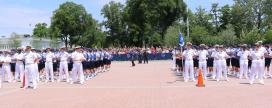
[70, 47, 85, 84]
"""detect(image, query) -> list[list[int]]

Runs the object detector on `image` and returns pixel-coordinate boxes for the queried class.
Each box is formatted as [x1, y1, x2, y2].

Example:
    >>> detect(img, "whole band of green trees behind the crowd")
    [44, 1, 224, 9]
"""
[30, 0, 272, 47]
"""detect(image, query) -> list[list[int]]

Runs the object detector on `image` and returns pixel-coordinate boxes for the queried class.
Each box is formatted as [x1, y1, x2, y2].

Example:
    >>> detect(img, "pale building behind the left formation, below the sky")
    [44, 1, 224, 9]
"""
[0, 35, 64, 50]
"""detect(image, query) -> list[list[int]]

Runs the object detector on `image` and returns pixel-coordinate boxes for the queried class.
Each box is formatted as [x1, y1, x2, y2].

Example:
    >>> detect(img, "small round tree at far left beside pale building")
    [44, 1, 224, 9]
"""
[33, 23, 49, 40]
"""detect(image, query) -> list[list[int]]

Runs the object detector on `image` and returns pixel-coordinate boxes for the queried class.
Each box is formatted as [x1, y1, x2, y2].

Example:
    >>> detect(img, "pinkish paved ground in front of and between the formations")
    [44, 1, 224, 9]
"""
[0, 61, 272, 108]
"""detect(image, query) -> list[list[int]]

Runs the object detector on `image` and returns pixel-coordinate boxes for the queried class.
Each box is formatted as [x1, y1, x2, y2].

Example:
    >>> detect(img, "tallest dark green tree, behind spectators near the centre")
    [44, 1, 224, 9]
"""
[125, 0, 186, 46]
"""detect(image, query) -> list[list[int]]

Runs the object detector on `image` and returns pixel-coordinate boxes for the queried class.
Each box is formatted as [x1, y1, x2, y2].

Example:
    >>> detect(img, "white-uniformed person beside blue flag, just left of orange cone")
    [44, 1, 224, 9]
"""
[182, 42, 196, 82]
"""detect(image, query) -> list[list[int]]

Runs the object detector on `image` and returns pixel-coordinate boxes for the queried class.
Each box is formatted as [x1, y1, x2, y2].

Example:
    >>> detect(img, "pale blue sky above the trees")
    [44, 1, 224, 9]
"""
[0, 0, 233, 38]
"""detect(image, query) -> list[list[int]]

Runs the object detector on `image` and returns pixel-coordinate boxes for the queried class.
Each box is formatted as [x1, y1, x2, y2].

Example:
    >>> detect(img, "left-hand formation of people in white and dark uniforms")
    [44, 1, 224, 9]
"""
[0, 46, 112, 89]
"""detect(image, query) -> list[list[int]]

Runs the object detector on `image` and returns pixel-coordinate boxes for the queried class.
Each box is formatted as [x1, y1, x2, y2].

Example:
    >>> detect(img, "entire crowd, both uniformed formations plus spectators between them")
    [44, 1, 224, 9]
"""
[0, 41, 272, 89]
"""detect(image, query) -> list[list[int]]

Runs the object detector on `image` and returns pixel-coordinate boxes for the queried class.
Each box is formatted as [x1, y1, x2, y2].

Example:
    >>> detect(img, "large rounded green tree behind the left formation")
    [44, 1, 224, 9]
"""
[50, 2, 94, 47]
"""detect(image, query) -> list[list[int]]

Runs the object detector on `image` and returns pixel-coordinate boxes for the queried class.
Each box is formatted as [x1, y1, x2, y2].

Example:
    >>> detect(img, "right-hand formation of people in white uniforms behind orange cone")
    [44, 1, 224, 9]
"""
[172, 41, 272, 85]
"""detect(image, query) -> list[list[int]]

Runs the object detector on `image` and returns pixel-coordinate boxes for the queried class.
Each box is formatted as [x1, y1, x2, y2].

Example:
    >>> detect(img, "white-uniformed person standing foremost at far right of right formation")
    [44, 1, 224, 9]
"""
[249, 43, 264, 85]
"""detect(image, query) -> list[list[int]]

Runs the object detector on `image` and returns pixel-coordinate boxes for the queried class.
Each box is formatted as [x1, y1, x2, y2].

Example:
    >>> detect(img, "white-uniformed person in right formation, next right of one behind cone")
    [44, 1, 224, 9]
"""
[216, 45, 229, 81]
